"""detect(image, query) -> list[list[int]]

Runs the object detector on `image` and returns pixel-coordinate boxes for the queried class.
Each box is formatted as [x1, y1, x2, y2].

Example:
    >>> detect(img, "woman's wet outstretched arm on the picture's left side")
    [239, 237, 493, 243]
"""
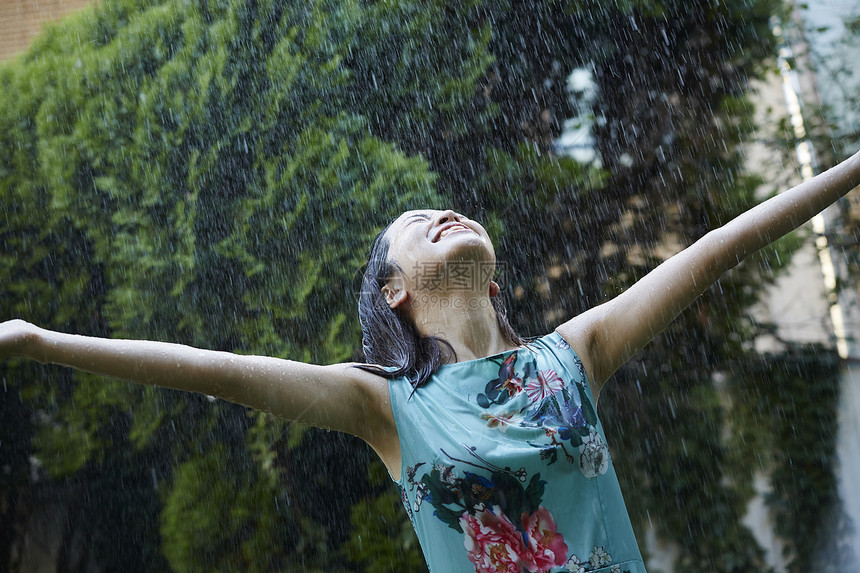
[0, 320, 396, 446]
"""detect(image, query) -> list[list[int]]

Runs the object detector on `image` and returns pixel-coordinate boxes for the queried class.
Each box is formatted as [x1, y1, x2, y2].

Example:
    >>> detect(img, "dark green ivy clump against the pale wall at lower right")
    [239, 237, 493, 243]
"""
[732, 346, 856, 572]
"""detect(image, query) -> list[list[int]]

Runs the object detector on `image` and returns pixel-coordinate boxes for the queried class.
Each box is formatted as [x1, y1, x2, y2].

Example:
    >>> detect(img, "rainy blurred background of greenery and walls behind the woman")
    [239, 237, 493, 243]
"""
[0, 0, 860, 573]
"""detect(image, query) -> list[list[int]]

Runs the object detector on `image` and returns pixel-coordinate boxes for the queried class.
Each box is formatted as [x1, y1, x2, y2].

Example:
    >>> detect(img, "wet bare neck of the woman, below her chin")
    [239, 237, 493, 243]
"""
[412, 293, 516, 362]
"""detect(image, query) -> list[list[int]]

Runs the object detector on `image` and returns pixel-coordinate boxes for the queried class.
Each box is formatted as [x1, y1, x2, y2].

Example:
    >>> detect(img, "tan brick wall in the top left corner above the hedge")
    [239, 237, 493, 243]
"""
[0, 0, 92, 60]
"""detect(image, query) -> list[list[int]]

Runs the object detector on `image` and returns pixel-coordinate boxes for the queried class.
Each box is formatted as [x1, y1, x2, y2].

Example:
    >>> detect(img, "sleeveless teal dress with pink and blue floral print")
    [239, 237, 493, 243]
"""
[389, 332, 645, 573]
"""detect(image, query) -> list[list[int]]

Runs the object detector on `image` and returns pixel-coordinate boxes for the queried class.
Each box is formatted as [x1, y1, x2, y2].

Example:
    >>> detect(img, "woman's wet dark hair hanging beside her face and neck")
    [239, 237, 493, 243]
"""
[356, 219, 524, 389]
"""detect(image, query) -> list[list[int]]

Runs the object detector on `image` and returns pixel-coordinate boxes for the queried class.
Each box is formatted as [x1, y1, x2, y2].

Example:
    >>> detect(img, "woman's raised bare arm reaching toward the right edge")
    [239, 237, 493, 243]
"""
[556, 152, 860, 396]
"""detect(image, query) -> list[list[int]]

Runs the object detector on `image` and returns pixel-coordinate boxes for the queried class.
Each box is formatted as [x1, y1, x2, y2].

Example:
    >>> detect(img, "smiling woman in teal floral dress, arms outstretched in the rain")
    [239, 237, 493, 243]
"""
[0, 149, 860, 573]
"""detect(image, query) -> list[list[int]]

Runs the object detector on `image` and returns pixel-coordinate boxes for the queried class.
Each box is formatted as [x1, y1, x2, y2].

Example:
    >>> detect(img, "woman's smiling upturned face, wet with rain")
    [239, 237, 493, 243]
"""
[386, 210, 496, 290]
